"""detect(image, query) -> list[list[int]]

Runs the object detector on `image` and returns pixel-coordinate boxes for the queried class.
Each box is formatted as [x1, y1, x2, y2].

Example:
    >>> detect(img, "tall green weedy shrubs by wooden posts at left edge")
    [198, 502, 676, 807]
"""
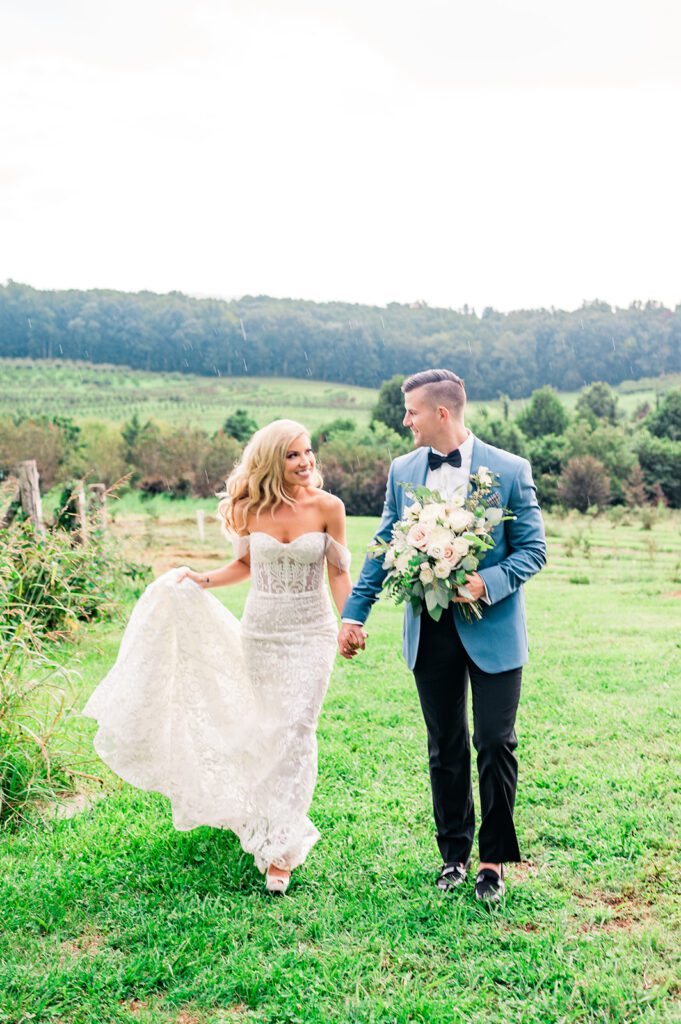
[0, 521, 150, 823]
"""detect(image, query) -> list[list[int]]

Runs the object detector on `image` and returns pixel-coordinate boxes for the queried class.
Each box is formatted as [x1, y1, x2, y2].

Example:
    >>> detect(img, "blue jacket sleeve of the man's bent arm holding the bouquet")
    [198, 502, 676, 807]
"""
[478, 459, 546, 604]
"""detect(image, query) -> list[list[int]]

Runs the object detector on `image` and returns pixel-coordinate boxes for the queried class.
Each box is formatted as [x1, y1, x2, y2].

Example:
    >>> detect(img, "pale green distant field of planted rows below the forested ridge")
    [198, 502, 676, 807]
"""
[0, 353, 681, 430]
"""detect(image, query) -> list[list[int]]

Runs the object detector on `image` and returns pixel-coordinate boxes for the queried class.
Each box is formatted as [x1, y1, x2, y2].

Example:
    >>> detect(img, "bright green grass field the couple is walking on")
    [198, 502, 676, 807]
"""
[0, 503, 681, 1024]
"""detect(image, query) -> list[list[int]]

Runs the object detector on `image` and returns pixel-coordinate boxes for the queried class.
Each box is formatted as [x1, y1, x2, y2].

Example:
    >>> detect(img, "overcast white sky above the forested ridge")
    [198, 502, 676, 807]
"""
[0, 0, 681, 311]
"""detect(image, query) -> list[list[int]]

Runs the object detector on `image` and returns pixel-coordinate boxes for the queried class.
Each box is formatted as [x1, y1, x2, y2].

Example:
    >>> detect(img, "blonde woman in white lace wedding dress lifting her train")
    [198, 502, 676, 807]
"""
[83, 420, 352, 893]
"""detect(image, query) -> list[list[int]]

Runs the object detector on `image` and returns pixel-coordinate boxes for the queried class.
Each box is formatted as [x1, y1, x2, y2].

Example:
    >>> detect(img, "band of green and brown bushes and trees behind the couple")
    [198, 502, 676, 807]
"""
[0, 376, 681, 515]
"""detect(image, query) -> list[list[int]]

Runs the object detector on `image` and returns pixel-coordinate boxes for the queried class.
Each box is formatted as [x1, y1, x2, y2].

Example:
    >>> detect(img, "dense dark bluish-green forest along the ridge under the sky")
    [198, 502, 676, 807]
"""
[0, 282, 681, 399]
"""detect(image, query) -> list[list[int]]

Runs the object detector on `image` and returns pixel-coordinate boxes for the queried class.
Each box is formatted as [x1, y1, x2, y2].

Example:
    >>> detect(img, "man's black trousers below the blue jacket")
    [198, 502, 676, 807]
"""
[414, 609, 522, 863]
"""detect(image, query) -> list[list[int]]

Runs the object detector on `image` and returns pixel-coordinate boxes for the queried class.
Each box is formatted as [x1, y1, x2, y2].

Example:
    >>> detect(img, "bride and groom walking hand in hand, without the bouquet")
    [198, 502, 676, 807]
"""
[83, 370, 546, 902]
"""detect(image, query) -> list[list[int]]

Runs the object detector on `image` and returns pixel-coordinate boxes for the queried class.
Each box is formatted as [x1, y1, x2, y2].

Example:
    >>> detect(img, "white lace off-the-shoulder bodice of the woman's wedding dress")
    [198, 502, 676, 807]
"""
[229, 530, 350, 594]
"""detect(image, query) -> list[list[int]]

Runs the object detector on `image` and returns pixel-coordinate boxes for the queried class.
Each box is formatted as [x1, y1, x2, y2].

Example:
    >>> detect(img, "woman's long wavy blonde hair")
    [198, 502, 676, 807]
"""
[217, 420, 324, 532]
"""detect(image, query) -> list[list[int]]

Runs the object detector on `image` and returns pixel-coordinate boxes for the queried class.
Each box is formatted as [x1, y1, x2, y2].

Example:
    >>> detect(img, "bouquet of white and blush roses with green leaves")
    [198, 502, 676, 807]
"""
[370, 466, 513, 622]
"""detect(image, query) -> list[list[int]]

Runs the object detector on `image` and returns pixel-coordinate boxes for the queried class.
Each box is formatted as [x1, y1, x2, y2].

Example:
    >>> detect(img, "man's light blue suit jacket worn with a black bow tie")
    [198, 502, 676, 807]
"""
[343, 437, 546, 672]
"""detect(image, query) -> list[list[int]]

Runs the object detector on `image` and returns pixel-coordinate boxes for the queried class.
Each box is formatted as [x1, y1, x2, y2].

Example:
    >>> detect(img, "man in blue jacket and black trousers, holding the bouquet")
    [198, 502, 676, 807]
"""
[338, 370, 546, 901]
